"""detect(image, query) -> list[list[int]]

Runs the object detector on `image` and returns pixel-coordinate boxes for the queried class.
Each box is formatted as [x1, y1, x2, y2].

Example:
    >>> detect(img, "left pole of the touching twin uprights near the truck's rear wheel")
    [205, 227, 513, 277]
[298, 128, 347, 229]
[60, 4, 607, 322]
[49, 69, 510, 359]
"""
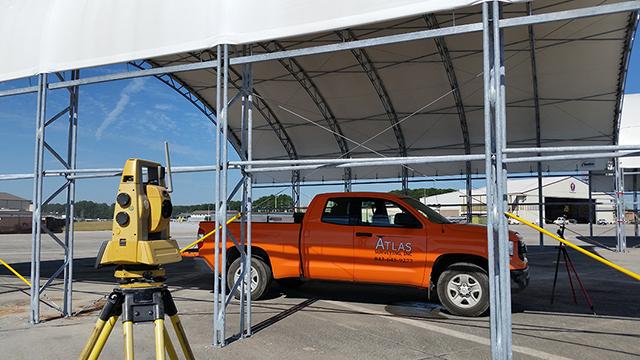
[211, 45, 226, 347]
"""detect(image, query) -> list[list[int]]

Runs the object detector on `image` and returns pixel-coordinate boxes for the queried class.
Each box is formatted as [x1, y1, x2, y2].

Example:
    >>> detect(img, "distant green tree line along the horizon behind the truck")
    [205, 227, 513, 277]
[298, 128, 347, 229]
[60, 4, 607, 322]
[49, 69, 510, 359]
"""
[42, 188, 455, 220]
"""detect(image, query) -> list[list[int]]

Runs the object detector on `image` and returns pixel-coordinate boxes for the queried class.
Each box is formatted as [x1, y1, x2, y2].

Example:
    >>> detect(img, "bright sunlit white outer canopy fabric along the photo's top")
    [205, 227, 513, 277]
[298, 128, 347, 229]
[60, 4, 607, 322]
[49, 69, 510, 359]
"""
[0, 0, 521, 81]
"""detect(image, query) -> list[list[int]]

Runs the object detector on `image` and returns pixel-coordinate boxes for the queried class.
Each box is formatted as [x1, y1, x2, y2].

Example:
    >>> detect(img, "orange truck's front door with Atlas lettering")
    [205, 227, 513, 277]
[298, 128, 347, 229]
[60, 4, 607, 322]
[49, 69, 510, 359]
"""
[353, 198, 427, 286]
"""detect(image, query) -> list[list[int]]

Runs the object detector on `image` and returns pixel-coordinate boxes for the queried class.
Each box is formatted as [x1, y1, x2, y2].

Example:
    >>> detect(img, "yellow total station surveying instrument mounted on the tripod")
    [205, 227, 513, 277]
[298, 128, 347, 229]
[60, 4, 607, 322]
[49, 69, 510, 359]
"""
[96, 159, 182, 265]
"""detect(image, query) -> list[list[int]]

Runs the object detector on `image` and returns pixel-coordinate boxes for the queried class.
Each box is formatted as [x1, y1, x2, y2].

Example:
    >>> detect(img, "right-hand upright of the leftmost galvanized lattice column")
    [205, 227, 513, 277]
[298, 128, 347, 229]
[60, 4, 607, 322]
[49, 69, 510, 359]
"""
[63, 70, 80, 317]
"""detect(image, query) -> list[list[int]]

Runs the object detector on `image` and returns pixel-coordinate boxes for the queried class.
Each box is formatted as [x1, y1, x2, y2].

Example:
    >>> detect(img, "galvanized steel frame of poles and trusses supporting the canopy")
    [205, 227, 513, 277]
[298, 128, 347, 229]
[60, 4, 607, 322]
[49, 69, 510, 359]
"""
[0, 0, 640, 359]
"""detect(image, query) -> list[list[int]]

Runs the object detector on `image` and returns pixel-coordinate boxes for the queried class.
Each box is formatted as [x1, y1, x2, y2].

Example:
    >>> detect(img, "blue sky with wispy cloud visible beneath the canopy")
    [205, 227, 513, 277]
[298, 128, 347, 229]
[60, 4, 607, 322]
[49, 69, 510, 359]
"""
[0, 47, 640, 205]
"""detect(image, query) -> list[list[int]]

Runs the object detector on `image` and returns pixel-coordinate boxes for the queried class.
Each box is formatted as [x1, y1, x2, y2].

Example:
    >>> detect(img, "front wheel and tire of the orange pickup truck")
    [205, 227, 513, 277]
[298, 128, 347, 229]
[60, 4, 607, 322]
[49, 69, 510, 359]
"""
[438, 263, 489, 317]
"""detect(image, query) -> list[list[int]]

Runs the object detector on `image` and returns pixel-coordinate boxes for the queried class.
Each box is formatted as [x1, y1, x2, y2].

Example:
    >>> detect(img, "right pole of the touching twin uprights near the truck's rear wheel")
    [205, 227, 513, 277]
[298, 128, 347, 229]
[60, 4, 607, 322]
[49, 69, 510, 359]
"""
[218, 44, 229, 346]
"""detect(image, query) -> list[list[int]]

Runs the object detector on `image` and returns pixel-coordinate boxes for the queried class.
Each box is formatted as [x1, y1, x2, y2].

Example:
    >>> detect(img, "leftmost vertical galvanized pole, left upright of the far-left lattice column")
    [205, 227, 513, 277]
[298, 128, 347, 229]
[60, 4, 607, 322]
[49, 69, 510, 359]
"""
[29, 74, 47, 324]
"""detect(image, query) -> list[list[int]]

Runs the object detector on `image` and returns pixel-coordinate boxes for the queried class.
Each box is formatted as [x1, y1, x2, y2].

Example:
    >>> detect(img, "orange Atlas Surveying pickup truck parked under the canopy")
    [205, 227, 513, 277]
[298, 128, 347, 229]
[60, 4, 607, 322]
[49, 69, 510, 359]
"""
[184, 192, 529, 316]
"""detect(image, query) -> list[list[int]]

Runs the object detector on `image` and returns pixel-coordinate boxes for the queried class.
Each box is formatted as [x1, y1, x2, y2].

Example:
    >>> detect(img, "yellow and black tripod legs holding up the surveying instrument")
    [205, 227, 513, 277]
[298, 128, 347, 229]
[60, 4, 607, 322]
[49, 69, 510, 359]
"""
[79, 265, 194, 360]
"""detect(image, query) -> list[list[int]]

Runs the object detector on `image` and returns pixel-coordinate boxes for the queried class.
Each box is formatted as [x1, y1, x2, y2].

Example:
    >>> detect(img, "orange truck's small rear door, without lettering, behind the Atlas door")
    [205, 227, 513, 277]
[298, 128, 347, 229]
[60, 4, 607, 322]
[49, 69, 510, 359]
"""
[302, 198, 354, 281]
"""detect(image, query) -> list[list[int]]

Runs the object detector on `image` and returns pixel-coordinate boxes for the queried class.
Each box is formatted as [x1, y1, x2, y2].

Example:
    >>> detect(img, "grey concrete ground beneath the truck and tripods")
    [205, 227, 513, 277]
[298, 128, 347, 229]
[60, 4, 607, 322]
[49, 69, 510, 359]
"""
[0, 223, 640, 360]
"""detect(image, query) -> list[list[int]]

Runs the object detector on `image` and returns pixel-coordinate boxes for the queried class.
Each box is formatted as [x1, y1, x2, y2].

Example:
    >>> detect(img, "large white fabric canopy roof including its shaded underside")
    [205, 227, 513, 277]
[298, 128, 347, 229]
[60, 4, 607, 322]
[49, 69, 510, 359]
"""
[0, 0, 637, 182]
